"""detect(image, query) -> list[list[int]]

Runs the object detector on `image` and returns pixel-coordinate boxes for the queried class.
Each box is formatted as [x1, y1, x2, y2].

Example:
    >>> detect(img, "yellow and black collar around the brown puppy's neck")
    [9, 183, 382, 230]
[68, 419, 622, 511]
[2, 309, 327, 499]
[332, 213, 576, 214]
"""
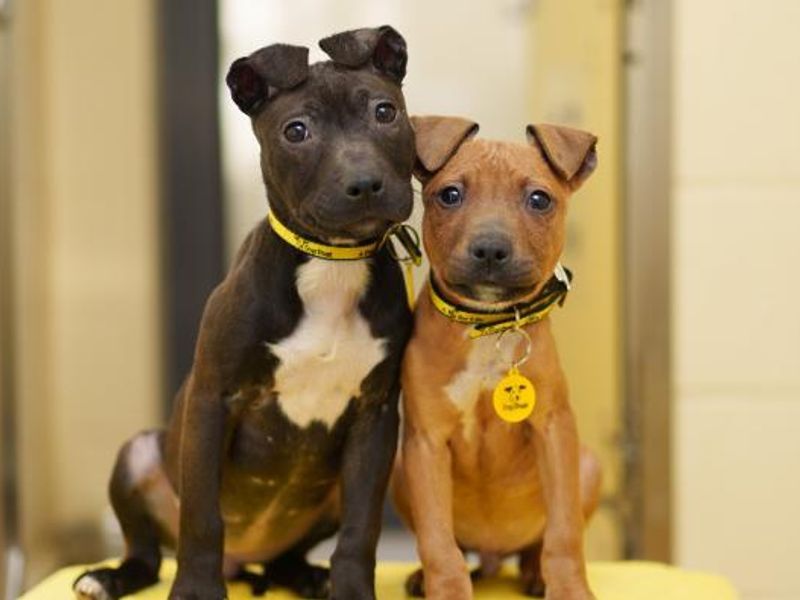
[428, 264, 572, 339]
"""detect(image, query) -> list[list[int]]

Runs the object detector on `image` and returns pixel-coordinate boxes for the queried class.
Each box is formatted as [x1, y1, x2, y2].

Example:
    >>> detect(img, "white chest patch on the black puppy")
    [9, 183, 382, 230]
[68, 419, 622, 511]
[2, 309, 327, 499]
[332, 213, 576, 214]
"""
[270, 258, 386, 427]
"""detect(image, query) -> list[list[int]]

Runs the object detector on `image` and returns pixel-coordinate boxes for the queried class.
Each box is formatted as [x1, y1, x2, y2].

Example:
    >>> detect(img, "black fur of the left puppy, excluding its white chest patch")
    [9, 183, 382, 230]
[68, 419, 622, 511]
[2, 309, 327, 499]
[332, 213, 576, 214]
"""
[75, 25, 414, 600]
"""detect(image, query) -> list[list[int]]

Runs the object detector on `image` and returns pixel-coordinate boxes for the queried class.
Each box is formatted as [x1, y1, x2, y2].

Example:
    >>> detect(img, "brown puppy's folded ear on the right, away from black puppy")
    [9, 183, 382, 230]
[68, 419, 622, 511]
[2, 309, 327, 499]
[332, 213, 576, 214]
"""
[527, 125, 597, 189]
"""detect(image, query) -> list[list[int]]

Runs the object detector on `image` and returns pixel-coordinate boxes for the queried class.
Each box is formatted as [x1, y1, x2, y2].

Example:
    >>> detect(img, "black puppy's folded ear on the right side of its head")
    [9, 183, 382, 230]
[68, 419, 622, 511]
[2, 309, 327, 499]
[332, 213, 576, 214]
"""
[319, 25, 408, 83]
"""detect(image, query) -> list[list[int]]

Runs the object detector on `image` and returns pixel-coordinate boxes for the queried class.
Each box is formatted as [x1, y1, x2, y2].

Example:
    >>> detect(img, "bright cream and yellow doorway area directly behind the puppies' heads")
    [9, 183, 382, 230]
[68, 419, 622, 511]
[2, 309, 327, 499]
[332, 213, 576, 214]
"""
[218, 0, 627, 559]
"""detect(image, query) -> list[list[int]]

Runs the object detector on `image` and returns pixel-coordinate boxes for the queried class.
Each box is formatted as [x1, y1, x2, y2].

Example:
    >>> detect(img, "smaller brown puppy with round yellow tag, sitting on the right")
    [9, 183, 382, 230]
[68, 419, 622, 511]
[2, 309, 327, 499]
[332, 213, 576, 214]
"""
[392, 117, 600, 600]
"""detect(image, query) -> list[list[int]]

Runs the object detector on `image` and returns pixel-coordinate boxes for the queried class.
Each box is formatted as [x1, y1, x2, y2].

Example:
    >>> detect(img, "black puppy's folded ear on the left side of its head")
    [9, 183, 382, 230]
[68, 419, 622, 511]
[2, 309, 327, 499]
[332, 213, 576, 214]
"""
[225, 44, 308, 117]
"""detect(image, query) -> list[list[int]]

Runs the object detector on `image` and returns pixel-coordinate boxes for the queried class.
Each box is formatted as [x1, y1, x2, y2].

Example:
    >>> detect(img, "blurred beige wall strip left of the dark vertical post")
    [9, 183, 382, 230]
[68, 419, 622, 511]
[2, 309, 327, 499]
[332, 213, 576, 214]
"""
[12, 0, 161, 578]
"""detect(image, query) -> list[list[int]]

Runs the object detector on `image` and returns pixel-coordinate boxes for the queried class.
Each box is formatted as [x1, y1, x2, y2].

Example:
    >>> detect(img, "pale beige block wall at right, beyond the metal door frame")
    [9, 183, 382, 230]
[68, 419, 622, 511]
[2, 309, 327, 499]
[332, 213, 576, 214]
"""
[673, 0, 800, 600]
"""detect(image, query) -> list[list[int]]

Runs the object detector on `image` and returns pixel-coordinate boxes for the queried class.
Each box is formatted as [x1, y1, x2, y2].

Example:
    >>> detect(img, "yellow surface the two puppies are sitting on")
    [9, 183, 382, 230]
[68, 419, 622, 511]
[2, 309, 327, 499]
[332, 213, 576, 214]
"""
[22, 561, 738, 600]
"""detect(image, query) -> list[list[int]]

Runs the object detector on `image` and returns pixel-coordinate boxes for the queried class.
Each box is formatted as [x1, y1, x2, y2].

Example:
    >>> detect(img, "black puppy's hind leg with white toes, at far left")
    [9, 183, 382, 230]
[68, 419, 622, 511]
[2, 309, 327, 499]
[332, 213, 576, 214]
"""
[73, 431, 178, 600]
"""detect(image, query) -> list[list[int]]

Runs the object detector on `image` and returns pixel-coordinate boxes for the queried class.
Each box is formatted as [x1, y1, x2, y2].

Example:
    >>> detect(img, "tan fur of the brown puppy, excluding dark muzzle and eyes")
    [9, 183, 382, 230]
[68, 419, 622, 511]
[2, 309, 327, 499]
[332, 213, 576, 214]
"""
[392, 123, 600, 600]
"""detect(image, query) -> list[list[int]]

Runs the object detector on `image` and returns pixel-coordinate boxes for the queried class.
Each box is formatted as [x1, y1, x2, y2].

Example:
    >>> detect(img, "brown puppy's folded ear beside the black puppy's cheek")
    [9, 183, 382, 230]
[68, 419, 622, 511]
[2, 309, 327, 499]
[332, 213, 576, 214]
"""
[411, 116, 478, 183]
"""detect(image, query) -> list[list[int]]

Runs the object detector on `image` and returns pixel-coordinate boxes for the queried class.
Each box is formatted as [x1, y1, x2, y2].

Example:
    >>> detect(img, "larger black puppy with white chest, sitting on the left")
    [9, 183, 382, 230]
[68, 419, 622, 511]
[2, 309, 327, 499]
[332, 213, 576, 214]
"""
[75, 26, 414, 600]
